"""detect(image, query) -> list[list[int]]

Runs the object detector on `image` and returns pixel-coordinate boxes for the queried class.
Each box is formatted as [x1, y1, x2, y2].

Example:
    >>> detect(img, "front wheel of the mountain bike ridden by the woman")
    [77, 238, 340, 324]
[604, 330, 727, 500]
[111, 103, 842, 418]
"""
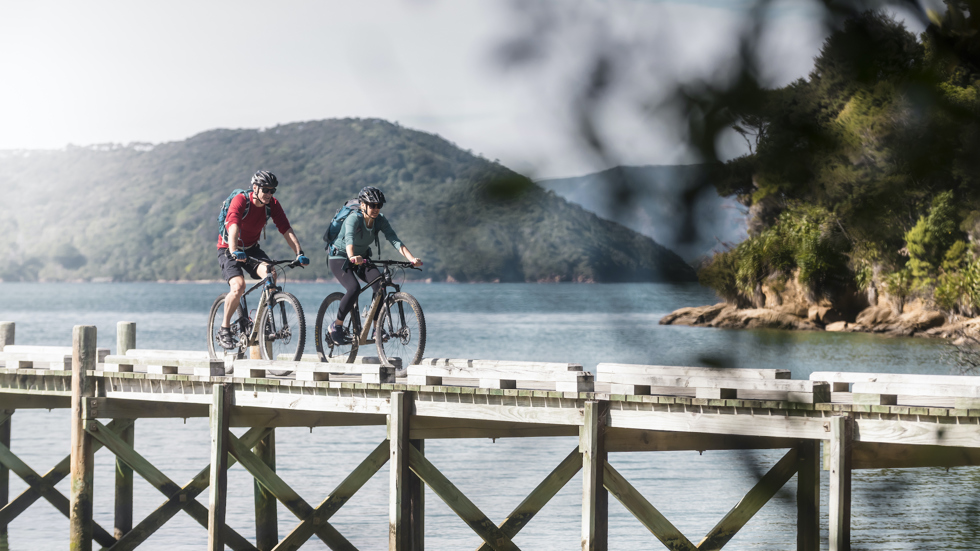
[374, 293, 425, 368]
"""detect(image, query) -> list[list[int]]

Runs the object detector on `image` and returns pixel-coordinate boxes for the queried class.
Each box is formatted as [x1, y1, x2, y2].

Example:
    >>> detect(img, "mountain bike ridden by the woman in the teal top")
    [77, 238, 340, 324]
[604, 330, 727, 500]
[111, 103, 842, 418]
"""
[315, 260, 425, 367]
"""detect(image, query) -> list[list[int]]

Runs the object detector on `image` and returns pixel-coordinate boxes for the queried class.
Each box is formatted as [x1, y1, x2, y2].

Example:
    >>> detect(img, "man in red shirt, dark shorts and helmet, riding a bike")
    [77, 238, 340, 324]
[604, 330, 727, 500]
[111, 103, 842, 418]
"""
[218, 170, 310, 349]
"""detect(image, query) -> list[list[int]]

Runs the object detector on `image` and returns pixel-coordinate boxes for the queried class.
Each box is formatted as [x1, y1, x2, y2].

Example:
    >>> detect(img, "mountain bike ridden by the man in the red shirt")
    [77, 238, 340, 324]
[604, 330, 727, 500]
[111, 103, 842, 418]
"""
[208, 260, 306, 376]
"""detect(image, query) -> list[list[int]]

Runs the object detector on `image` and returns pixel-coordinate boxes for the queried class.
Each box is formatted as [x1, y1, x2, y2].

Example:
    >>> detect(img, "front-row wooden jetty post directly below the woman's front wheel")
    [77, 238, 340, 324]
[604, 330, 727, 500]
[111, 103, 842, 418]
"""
[388, 392, 412, 551]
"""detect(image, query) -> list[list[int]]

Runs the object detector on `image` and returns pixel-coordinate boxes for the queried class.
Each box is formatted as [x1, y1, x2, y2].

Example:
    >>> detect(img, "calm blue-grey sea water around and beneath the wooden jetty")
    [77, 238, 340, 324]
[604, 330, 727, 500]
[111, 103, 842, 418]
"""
[0, 283, 980, 551]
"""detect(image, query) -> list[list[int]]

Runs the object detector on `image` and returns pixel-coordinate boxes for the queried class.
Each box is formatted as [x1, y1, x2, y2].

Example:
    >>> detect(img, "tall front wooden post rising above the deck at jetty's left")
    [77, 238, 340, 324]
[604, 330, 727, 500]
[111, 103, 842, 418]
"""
[68, 325, 98, 551]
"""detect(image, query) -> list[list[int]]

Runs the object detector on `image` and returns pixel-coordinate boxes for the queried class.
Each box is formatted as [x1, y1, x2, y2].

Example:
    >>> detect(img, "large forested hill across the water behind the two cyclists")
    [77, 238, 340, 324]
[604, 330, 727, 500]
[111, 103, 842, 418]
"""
[0, 119, 696, 282]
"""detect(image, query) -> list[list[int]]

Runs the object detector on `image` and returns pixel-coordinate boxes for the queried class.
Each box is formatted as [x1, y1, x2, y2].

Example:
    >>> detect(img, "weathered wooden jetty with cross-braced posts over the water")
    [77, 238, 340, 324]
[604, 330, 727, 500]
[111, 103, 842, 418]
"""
[0, 322, 980, 551]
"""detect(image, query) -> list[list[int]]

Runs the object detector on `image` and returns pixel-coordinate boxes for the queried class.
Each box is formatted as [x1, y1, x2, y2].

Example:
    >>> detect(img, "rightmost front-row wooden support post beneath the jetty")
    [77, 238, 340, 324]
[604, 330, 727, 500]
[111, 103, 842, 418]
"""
[828, 417, 854, 551]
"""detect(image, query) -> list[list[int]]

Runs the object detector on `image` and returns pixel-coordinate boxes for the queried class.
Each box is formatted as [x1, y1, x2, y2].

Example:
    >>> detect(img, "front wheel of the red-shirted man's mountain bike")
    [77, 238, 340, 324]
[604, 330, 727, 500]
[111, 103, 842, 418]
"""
[259, 292, 306, 375]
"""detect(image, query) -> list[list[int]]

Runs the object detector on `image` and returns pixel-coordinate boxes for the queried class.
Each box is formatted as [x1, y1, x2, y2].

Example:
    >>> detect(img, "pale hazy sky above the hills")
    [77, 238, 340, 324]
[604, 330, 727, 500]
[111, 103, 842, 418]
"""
[0, 0, 919, 177]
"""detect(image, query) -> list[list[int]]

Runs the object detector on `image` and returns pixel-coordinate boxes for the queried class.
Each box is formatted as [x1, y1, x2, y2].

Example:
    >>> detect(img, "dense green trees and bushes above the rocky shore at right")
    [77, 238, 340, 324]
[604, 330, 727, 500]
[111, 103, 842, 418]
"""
[704, 7, 980, 308]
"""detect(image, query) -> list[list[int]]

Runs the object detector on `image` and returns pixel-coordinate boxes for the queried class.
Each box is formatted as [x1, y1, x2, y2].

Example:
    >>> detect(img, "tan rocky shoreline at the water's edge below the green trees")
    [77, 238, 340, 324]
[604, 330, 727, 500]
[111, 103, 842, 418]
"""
[660, 302, 980, 341]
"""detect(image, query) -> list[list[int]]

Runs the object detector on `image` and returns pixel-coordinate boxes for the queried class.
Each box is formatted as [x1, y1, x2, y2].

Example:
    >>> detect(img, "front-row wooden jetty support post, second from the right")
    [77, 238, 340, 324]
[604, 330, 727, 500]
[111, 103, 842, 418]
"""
[579, 400, 609, 551]
